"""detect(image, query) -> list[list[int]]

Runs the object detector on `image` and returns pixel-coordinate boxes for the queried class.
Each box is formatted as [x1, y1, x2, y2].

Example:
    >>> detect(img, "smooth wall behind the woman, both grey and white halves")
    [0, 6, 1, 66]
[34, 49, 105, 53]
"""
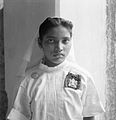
[4, 0, 106, 116]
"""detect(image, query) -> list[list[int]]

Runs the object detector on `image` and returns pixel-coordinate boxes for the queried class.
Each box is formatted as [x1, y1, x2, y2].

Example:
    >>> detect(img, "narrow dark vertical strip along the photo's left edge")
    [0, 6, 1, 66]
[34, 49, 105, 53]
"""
[0, 7, 8, 120]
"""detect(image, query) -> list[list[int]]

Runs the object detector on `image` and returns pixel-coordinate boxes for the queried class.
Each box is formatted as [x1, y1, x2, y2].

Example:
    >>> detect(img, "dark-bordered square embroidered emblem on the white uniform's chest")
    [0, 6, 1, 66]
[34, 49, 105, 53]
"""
[64, 72, 81, 90]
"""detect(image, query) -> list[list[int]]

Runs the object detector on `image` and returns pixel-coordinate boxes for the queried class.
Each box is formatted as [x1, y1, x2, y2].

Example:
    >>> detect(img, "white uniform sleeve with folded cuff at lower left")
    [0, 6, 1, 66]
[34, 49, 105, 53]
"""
[7, 78, 31, 120]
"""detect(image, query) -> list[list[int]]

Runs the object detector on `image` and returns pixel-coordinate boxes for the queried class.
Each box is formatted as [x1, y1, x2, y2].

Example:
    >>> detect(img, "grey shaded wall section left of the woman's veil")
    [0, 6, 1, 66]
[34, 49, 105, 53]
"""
[4, 0, 55, 112]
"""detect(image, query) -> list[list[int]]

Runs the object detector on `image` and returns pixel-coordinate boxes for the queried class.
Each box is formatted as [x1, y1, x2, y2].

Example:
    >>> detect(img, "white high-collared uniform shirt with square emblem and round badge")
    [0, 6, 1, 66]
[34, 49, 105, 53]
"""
[8, 61, 104, 120]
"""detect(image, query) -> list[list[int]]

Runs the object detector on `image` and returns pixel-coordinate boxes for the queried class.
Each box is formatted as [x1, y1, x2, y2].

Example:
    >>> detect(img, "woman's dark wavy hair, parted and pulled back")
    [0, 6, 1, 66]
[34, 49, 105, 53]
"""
[39, 17, 73, 42]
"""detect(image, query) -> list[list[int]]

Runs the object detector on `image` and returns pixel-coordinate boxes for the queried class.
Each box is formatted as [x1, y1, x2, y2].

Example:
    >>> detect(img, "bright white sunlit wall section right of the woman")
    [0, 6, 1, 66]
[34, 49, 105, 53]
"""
[60, 0, 106, 106]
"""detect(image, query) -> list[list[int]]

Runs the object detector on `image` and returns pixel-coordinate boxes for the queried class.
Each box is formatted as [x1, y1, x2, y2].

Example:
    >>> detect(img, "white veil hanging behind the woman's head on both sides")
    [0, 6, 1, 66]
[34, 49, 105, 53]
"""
[17, 20, 76, 77]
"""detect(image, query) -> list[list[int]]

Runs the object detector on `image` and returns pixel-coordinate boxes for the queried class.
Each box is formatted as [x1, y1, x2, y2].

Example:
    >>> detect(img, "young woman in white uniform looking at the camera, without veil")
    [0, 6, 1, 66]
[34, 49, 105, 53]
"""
[8, 17, 104, 120]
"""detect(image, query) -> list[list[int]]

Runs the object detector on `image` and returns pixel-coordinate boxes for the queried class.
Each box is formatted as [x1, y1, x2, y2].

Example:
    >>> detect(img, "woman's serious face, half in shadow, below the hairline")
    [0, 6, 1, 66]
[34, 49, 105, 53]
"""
[42, 26, 71, 67]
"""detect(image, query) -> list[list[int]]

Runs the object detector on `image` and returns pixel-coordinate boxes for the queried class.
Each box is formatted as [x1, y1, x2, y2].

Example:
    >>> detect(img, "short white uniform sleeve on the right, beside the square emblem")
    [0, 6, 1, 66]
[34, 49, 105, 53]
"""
[82, 75, 105, 117]
